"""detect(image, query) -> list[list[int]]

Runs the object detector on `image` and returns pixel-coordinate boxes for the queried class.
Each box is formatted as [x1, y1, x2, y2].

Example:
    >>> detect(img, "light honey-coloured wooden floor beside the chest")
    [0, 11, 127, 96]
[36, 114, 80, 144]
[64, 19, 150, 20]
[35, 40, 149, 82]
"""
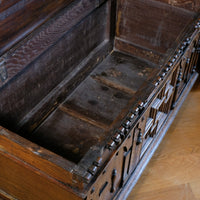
[127, 81, 200, 200]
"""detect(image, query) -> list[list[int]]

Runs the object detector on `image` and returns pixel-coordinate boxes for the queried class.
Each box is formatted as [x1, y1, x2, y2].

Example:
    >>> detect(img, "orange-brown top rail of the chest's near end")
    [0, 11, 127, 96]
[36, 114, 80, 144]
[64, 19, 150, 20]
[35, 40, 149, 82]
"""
[0, 129, 81, 189]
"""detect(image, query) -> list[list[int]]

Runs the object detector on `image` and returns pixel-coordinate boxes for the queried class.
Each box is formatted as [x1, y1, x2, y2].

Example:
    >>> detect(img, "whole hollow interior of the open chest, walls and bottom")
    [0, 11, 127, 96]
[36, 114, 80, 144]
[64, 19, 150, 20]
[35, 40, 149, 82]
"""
[0, 0, 196, 163]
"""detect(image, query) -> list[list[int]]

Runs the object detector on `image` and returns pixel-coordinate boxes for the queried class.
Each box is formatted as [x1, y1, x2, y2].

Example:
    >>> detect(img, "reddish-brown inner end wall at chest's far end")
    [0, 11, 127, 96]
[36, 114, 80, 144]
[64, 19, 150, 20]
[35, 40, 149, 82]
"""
[116, 0, 195, 54]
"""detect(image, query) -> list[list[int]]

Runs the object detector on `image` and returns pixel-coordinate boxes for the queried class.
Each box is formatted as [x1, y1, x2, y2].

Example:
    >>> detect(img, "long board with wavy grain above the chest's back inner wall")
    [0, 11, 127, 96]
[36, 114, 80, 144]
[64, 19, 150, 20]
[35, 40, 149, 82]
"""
[0, 0, 101, 86]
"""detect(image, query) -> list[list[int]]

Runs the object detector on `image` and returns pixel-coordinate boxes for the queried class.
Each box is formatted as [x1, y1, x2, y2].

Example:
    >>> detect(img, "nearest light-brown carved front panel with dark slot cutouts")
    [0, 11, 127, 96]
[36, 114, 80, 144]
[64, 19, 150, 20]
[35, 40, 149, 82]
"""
[87, 119, 145, 200]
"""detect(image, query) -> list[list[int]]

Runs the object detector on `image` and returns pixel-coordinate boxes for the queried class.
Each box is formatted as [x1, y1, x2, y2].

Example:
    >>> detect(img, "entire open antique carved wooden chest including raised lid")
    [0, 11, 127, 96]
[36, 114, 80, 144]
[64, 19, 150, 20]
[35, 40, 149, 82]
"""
[0, 0, 200, 200]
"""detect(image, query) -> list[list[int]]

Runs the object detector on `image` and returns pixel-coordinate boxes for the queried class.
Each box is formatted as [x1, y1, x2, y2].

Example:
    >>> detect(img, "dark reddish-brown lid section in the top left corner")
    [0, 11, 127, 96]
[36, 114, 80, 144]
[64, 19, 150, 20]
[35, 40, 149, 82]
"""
[0, 0, 73, 54]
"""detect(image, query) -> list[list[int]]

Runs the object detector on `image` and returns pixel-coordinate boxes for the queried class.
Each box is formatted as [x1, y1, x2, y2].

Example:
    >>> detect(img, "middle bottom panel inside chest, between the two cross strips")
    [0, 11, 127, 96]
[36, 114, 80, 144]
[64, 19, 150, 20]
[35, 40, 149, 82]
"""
[64, 78, 132, 126]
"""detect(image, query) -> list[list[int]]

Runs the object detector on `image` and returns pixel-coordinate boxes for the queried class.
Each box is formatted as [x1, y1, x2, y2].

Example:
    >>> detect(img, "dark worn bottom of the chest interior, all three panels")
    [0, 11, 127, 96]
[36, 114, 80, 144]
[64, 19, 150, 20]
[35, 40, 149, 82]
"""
[29, 51, 159, 162]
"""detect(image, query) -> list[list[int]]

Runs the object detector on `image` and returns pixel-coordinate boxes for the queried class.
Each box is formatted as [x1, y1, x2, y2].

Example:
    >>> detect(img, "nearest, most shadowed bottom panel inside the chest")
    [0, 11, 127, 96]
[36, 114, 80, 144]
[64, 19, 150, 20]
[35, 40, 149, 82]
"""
[30, 108, 107, 164]
